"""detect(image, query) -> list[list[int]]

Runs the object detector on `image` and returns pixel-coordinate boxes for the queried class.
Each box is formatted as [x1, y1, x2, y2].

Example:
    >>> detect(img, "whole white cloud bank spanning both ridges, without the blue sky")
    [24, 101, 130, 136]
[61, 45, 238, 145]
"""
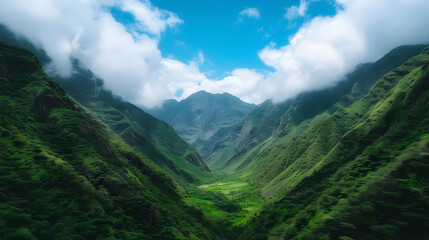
[0, 0, 429, 107]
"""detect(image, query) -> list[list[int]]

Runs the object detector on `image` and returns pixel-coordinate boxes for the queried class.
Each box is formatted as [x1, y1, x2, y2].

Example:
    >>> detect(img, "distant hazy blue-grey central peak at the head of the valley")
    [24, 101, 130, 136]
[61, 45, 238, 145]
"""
[146, 91, 255, 159]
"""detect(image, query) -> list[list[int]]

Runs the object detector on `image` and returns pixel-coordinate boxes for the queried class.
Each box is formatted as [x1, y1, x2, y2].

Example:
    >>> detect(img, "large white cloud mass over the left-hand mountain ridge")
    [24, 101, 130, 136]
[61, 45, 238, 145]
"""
[0, 0, 196, 107]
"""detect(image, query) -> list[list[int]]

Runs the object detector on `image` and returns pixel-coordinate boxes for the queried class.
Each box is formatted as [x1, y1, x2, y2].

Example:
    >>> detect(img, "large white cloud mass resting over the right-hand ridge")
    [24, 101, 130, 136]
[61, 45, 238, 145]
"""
[206, 0, 429, 103]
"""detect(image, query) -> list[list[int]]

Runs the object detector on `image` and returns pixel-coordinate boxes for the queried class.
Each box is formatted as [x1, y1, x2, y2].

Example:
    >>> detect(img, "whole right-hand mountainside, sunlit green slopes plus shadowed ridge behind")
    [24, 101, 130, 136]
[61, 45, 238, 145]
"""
[144, 45, 429, 239]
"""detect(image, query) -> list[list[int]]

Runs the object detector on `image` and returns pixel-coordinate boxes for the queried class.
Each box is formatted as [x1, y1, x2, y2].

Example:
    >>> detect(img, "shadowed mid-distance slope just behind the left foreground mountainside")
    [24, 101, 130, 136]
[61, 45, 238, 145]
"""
[55, 76, 210, 183]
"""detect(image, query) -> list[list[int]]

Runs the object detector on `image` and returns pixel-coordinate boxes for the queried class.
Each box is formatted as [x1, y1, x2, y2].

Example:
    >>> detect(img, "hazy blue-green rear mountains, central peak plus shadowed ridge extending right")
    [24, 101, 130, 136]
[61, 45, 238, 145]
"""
[145, 45, 425, 172]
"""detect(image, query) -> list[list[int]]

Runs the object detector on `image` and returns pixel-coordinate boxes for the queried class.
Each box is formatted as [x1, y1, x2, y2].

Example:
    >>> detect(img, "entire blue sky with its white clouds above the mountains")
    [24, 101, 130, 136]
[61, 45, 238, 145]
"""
[0, 0, 429, 108]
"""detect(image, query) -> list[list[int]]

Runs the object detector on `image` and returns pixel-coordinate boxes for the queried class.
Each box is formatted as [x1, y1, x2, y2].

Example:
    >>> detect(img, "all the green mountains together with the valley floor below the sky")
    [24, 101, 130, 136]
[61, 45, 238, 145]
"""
[0, 29, 429, 240]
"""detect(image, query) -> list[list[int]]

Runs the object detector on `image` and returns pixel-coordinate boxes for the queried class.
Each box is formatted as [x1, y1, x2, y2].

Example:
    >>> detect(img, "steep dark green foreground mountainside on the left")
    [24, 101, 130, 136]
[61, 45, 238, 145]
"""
[0, 43, 222, 239]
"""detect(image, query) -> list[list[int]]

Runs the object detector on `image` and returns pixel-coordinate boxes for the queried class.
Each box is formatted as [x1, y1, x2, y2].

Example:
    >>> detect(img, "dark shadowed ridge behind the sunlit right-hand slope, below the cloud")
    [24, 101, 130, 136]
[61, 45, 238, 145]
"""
[207, 45, 425, 169]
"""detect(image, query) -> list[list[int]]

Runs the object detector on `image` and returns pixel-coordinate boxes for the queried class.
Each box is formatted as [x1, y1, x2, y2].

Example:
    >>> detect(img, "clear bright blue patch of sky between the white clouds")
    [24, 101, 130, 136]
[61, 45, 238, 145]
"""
[147, 0, 336, 79]
